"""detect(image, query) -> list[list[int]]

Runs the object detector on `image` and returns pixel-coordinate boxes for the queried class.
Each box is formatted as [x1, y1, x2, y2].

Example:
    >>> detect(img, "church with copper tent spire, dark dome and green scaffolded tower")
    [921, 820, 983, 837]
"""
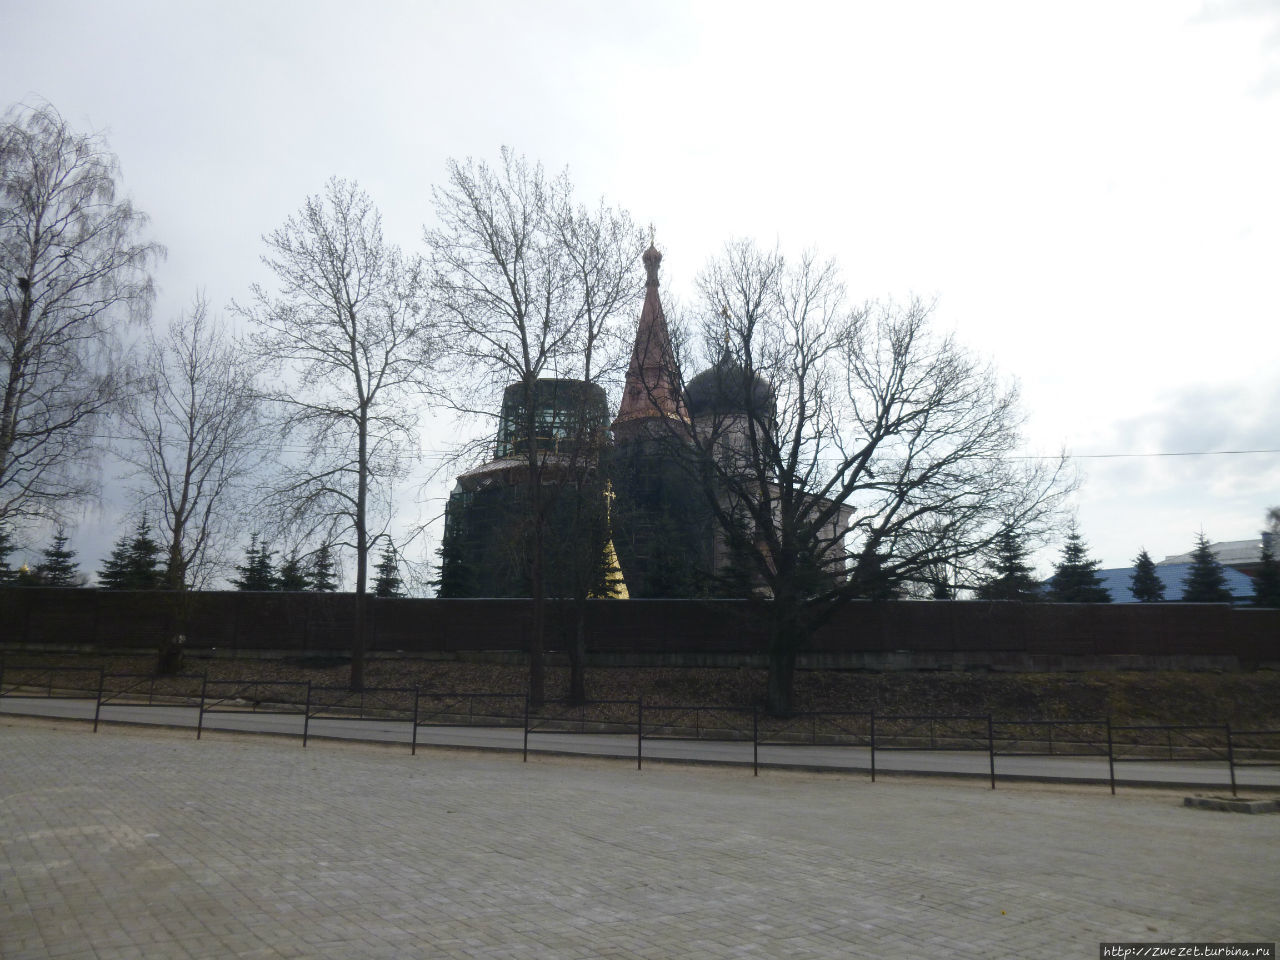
[439, 244, 803, 598]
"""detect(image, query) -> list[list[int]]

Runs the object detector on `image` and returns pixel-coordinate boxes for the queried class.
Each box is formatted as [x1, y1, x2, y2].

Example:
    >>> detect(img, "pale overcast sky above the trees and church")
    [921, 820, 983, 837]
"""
[0, 0, 1280, 586]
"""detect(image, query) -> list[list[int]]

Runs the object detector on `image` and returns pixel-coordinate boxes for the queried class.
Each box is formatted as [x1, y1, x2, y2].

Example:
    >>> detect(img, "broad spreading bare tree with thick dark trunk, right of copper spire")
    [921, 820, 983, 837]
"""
[666, 243, 1071, 713]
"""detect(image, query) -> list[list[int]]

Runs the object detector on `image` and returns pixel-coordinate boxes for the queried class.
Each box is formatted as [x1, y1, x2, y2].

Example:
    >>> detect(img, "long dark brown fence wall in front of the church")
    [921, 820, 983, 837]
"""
[0, 588, 1280, 669]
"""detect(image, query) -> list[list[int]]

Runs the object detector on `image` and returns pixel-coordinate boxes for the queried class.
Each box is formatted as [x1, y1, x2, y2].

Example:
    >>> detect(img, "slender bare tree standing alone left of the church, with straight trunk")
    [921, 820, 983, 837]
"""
[238, 178, 438, 690]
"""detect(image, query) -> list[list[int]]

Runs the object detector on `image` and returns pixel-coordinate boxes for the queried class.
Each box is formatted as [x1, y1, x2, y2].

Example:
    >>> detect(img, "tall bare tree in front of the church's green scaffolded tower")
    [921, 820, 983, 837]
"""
[425, 148, 643, 703]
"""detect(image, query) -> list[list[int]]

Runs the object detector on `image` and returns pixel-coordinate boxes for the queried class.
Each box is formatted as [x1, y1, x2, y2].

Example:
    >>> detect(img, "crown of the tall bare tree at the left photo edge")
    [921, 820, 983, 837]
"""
[0, 104, 163, 522]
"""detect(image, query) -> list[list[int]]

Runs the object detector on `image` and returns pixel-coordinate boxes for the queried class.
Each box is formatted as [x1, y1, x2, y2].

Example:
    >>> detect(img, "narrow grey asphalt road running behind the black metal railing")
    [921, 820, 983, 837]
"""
[0, 696, 1280, 788]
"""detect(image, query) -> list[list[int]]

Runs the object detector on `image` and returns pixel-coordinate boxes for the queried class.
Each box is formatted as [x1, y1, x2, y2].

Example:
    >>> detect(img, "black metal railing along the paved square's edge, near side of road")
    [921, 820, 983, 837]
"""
[0, 662, 1280, 795]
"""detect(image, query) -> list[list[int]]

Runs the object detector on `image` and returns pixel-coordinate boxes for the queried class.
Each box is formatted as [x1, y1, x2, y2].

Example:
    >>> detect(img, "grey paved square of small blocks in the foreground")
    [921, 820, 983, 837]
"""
[0, 718, 1280, 960]
